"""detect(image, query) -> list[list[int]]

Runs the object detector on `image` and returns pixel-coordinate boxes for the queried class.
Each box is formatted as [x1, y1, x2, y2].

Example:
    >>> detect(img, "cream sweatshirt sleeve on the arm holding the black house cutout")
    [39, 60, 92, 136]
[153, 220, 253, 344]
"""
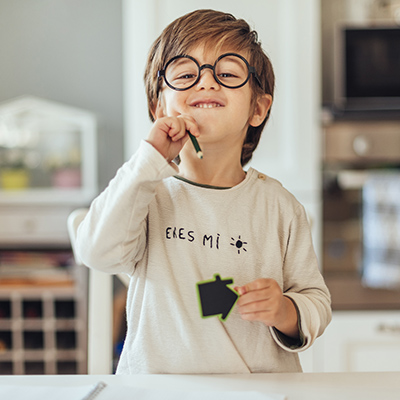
[270, 206, 332, 352]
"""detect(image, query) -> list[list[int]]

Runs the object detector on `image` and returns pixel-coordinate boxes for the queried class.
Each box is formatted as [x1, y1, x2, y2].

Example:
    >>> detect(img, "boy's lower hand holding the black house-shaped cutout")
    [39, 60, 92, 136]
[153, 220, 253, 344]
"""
[235, 279, 299, 337]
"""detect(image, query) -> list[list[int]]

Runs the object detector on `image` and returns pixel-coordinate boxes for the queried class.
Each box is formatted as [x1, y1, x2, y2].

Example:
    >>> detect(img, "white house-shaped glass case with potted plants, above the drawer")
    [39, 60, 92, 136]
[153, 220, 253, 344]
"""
[0, 96, 97, 206]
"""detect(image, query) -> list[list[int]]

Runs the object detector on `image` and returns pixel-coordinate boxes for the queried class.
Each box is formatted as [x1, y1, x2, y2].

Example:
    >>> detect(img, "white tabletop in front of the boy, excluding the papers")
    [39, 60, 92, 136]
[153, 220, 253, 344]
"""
[0, 372, 400, 400]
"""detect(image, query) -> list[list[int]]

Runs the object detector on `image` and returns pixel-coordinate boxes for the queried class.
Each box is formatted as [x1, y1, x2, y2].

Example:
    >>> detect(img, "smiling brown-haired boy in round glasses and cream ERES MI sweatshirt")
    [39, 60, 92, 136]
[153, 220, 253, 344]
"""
[76, 10, 331, 374]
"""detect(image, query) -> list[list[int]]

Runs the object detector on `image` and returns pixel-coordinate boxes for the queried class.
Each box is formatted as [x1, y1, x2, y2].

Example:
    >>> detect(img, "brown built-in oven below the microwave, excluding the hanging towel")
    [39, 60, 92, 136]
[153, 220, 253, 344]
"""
[323, 120, 400, 284]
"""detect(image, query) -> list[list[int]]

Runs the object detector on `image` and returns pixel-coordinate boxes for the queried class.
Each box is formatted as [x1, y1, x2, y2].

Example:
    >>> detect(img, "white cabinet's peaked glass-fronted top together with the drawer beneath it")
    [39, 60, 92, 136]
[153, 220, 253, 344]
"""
[0, 96, 97, 248]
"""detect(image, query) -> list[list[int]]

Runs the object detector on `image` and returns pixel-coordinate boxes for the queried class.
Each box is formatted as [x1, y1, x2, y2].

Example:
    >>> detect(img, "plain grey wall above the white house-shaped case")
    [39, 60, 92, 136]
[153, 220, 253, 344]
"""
[0, 0, 123, 194]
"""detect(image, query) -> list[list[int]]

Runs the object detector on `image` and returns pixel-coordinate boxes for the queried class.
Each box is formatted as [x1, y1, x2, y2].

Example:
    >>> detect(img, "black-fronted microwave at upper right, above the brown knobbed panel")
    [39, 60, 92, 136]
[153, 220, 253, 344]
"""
[334, 25, 400, 111]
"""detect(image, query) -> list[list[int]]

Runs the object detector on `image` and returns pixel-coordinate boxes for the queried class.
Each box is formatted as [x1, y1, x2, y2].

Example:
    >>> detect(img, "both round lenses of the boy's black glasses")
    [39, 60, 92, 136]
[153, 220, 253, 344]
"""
[165, 55, 249, 90]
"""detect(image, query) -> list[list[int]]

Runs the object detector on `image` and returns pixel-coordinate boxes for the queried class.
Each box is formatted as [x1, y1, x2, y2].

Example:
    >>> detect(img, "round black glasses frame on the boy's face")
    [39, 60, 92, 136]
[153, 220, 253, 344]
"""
[157, 53, 262, 92]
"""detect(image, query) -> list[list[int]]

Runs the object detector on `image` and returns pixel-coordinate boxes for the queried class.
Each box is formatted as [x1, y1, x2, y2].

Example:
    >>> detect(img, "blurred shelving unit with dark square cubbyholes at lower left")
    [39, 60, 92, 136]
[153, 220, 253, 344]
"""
[0, 260, 87, 375]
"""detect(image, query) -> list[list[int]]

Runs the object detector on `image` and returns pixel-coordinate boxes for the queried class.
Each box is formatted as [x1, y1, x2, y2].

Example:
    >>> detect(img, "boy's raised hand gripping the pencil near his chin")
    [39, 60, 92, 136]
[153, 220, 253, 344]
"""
[147, 115, 199, 162]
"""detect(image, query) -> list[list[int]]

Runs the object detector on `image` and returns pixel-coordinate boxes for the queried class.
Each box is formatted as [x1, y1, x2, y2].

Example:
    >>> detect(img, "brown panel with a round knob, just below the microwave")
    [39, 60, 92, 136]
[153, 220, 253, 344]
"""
[324, 121, 400, 164]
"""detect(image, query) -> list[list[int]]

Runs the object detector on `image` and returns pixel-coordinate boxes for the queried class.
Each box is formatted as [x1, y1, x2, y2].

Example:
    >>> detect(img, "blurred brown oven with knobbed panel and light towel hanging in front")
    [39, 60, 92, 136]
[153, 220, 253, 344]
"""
[322, 120, 400, 289]
